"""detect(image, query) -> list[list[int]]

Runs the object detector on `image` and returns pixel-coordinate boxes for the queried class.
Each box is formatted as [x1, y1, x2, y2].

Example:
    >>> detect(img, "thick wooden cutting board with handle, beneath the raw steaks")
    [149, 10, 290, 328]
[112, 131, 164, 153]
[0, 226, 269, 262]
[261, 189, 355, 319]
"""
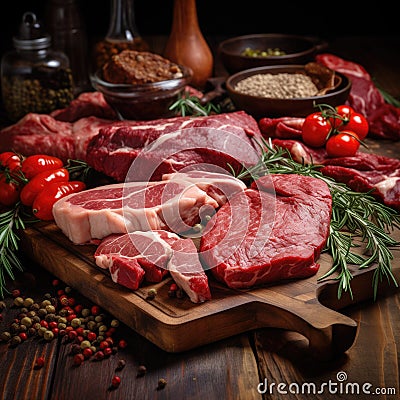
[21, 223, 400, 359]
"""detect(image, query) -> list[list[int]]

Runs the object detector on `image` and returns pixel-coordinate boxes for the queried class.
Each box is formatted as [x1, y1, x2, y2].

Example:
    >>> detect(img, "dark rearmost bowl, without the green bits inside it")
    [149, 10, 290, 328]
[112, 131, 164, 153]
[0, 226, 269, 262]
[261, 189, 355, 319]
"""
[218, 33, 328, 74]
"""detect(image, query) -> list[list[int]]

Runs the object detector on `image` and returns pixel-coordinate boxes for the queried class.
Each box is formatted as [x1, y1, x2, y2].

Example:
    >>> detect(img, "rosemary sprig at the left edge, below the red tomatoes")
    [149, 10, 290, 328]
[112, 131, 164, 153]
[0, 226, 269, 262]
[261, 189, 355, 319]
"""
[0, 203, 34, 298]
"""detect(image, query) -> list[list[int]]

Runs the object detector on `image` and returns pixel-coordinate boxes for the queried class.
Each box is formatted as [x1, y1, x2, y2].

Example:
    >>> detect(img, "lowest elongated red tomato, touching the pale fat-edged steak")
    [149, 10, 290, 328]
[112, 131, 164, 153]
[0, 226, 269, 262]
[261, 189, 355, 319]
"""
[32, 181, 86, 221]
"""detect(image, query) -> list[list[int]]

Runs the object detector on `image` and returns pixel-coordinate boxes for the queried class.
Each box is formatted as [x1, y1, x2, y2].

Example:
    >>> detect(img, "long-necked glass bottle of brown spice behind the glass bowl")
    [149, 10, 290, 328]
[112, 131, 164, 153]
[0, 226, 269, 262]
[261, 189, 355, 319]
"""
[94, 0, 149, 70]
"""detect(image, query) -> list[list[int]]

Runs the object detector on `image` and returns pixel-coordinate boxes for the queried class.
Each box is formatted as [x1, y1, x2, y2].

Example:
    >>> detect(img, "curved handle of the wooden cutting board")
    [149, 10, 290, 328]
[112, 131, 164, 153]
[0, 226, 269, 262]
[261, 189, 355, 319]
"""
[256, 293, 357, 360]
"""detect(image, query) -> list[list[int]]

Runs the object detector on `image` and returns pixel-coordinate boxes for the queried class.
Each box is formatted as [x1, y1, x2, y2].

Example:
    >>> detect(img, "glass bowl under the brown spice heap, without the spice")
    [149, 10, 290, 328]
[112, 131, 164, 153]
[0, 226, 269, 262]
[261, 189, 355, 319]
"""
[90, 65, 193, 120]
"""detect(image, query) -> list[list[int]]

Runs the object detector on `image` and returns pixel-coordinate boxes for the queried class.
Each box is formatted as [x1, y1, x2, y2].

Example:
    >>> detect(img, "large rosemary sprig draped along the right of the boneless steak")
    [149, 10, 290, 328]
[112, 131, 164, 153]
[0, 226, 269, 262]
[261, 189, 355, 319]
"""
[237, 140, 400, 298]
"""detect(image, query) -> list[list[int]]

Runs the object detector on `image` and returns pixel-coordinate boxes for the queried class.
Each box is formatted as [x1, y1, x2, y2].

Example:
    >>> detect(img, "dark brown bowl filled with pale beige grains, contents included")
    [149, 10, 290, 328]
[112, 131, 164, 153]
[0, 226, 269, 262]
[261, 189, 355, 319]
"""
[225, 63, 351, 119]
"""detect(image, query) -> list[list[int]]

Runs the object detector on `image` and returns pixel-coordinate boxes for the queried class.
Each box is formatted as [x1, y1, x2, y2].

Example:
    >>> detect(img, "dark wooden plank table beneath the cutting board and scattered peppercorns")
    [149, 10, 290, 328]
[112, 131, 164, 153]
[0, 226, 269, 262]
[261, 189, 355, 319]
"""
[0, 36, 400, 400]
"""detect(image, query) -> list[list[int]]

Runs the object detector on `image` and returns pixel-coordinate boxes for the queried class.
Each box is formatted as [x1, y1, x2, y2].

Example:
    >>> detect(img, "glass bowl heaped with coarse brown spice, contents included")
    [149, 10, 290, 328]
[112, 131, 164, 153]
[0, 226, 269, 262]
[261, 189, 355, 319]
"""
[90, 50, 193, 120]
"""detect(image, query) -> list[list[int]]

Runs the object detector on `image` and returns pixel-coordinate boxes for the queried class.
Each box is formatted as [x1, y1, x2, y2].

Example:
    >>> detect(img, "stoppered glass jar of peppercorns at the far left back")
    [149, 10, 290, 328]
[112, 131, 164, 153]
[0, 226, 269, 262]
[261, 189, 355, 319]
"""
[1, 12, 74, 122]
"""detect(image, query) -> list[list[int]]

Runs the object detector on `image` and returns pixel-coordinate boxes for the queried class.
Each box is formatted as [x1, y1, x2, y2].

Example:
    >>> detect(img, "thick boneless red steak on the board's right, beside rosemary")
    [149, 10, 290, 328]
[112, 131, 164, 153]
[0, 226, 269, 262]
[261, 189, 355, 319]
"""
[199, 175, 332, 288]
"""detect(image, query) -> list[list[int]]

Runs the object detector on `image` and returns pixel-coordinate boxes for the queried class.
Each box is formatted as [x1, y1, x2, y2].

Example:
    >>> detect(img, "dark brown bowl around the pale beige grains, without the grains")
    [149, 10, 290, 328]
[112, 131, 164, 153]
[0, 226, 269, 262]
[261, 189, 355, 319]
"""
[225, 65, 351, 119]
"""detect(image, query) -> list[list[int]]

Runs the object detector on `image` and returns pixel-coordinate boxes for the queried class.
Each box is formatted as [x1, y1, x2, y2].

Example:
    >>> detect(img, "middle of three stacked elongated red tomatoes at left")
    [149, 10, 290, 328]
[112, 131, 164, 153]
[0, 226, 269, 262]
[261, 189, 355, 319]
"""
[20, 168, 69, 206]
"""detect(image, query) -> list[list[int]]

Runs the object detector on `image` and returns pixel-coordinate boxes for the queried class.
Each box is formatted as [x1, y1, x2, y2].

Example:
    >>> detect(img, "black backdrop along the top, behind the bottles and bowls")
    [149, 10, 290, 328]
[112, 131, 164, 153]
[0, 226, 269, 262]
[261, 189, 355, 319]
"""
[0, 0, 400, 53]
